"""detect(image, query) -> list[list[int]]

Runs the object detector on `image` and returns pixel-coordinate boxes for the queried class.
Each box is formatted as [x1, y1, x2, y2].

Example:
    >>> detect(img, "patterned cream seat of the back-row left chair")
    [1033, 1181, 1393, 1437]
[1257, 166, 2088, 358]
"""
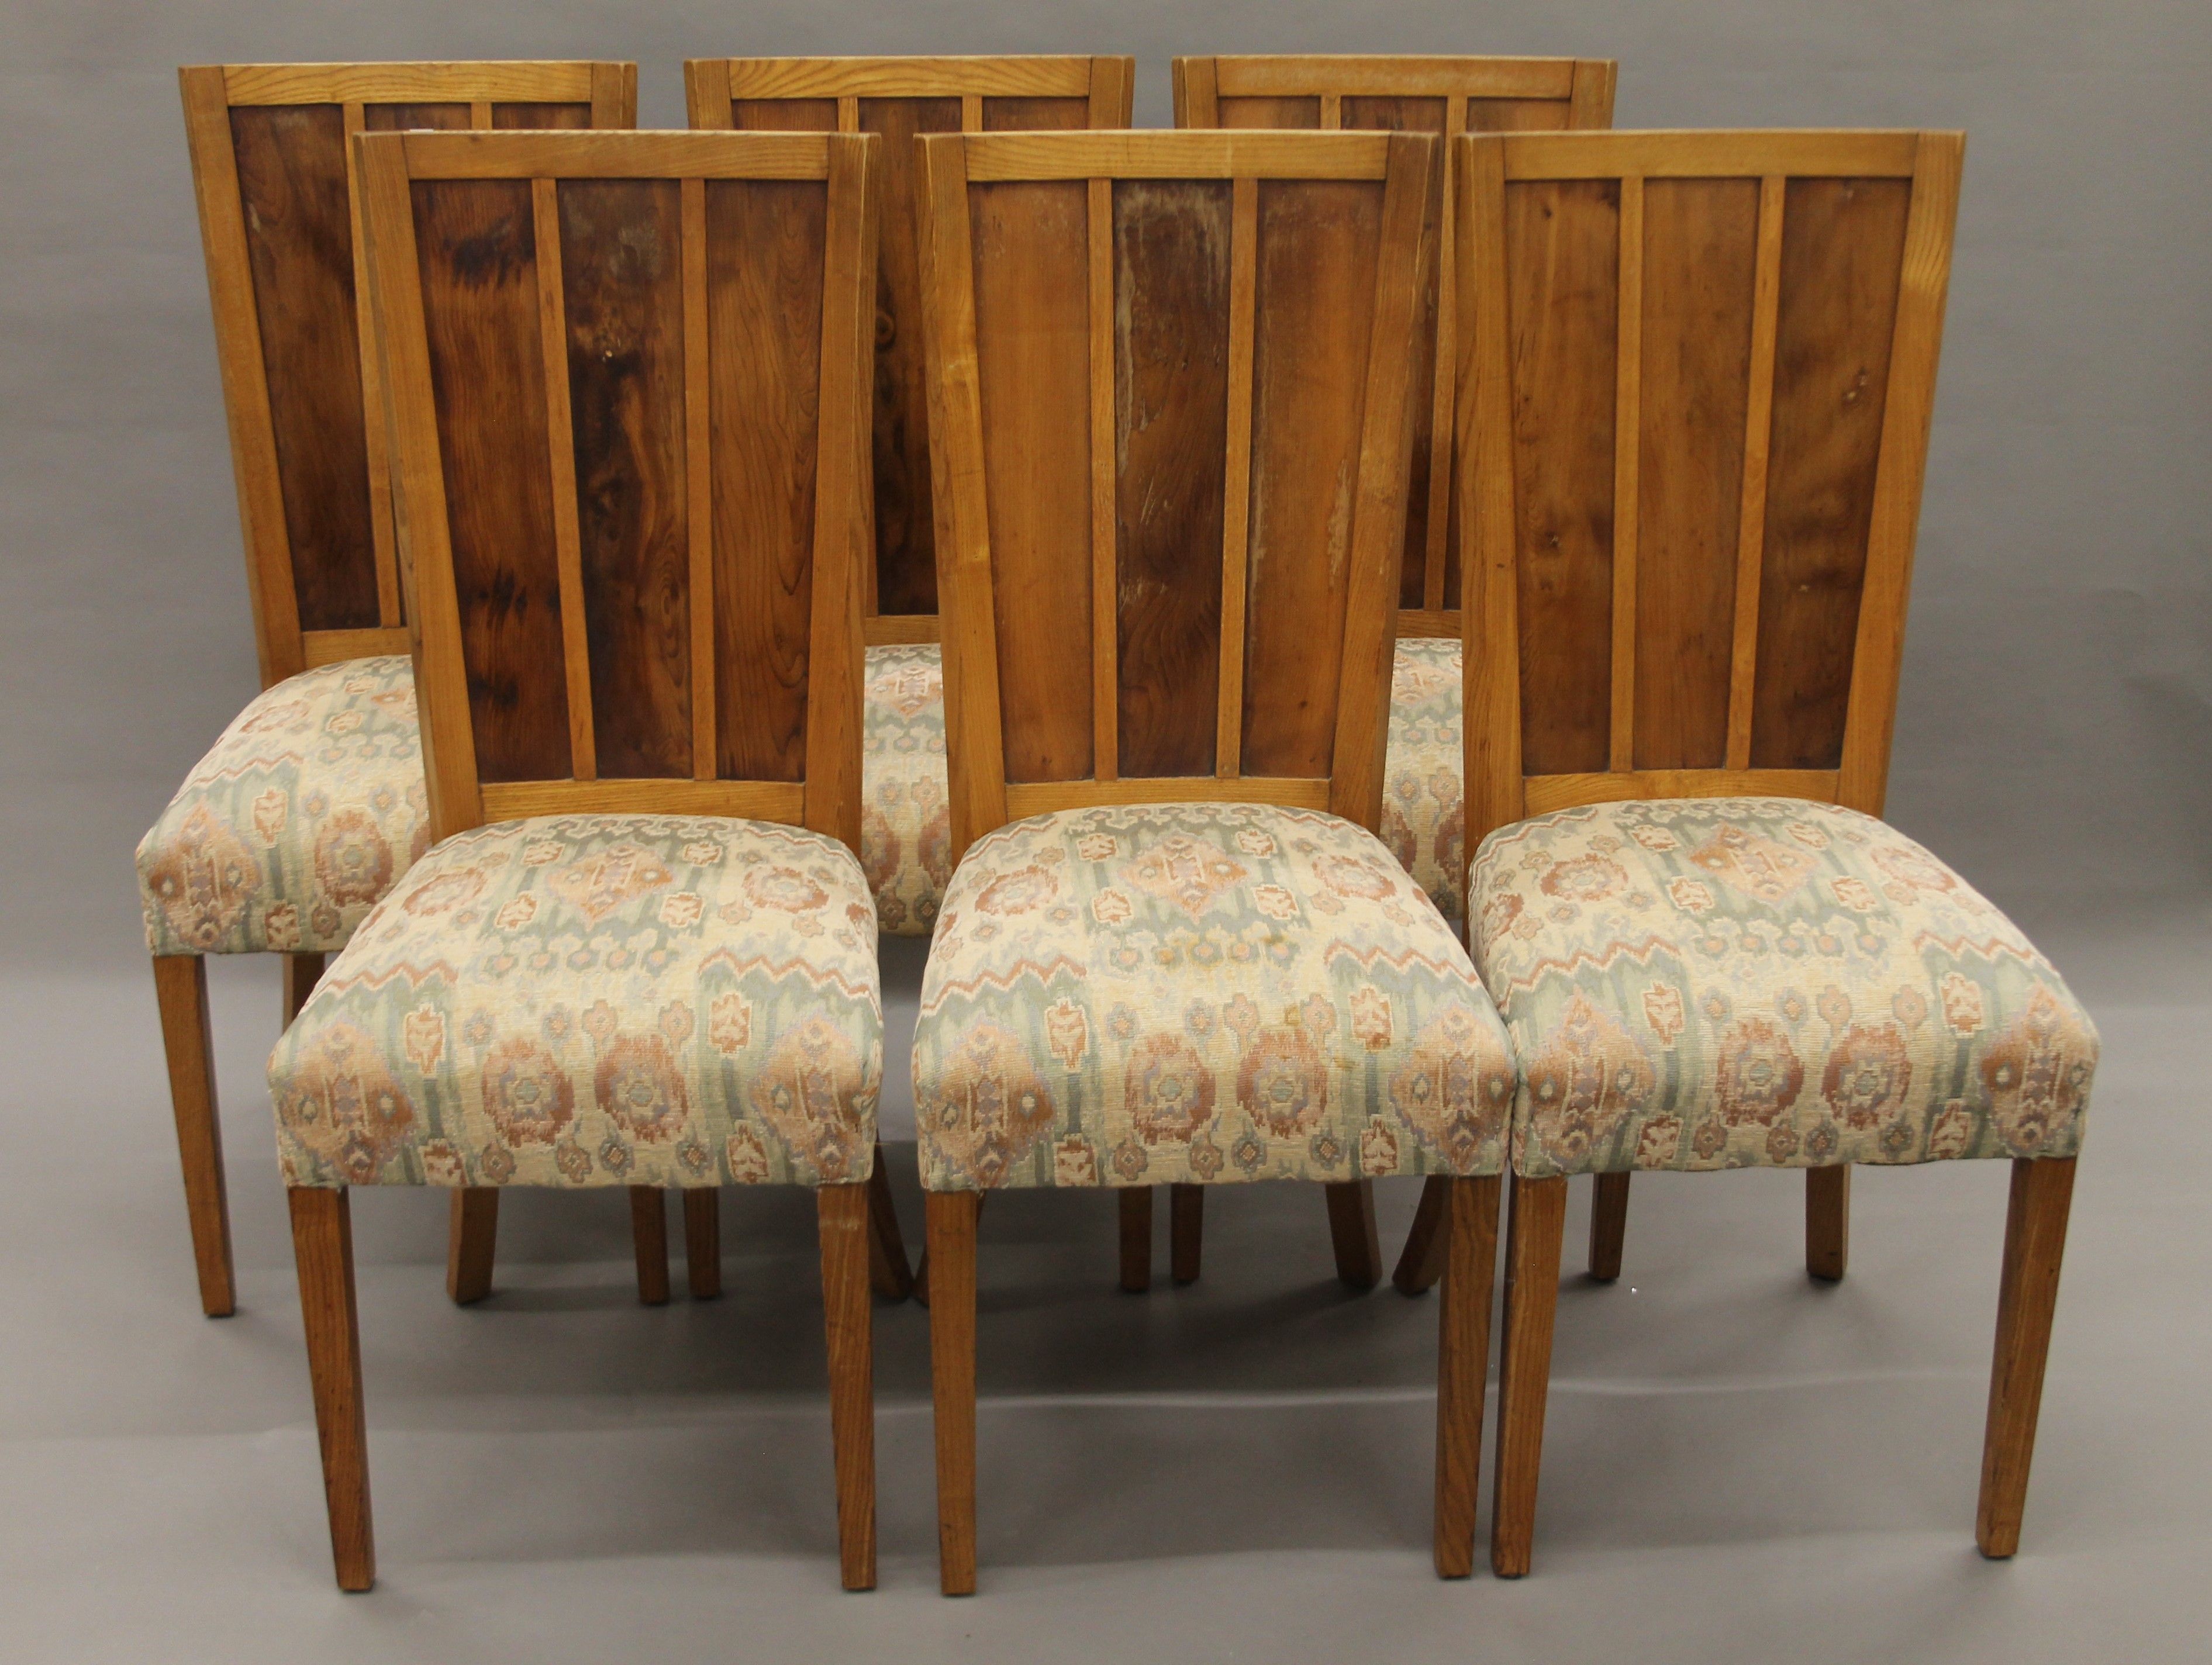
[137, 657, 429, 953]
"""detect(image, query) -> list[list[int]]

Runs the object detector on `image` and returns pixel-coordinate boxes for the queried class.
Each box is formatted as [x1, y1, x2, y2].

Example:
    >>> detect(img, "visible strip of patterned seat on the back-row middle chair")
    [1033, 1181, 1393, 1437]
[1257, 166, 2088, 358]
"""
[861, 644, 953, 938]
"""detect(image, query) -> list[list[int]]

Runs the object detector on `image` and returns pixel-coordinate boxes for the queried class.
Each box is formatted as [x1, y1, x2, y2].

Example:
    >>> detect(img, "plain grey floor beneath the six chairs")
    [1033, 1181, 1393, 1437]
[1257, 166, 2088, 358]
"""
[0, 904, 2212, 1665]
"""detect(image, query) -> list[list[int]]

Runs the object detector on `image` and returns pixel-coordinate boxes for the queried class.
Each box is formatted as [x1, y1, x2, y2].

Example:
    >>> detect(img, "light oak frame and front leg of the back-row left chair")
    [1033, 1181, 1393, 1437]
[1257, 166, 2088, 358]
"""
[153, 62, 637, 1318]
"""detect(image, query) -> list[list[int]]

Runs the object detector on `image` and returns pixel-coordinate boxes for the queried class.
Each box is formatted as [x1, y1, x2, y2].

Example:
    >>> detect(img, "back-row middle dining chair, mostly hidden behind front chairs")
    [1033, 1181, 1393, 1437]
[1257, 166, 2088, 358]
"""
[684, 57, 1137, 938]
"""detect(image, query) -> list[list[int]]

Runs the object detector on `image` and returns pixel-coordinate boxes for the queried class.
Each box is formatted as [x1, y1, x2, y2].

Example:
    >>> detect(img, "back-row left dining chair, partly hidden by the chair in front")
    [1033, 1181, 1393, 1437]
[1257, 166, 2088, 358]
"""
[151, 62, 637, 1318]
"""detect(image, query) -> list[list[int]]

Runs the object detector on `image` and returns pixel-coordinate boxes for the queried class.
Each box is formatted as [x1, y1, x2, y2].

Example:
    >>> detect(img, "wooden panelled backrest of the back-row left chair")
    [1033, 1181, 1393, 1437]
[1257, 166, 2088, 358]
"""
[177, 64, 637, 688]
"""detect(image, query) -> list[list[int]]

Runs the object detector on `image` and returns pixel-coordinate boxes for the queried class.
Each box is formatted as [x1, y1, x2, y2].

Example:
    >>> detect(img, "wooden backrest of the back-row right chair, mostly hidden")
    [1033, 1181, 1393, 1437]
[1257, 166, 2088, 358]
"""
[1175, 53, 1615, 637]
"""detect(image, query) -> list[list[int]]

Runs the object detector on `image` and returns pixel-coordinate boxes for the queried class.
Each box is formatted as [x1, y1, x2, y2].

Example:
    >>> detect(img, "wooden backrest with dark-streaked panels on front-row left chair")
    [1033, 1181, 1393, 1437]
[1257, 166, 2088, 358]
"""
[358, 133, 881, 847]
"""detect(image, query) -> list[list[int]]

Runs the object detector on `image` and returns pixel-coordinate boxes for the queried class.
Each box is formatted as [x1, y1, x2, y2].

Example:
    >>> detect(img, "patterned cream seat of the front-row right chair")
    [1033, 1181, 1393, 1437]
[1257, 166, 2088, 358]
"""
[1469, 798, 2097, 1176]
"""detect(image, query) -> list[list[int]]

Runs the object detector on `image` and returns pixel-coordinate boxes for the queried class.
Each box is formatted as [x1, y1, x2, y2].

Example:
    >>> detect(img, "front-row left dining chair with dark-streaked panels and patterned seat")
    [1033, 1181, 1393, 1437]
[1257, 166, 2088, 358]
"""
[268, 133, 882, 1590]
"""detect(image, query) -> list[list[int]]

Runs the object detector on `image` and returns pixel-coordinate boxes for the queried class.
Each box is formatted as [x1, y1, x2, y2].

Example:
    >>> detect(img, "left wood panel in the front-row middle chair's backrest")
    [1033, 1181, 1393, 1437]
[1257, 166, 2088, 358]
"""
[969, 179, 1093, 780]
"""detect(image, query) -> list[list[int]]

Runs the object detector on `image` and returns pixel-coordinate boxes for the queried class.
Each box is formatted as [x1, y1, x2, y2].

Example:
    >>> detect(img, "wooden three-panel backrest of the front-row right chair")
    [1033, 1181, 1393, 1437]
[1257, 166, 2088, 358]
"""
[1458, 133, 1964, 849]
